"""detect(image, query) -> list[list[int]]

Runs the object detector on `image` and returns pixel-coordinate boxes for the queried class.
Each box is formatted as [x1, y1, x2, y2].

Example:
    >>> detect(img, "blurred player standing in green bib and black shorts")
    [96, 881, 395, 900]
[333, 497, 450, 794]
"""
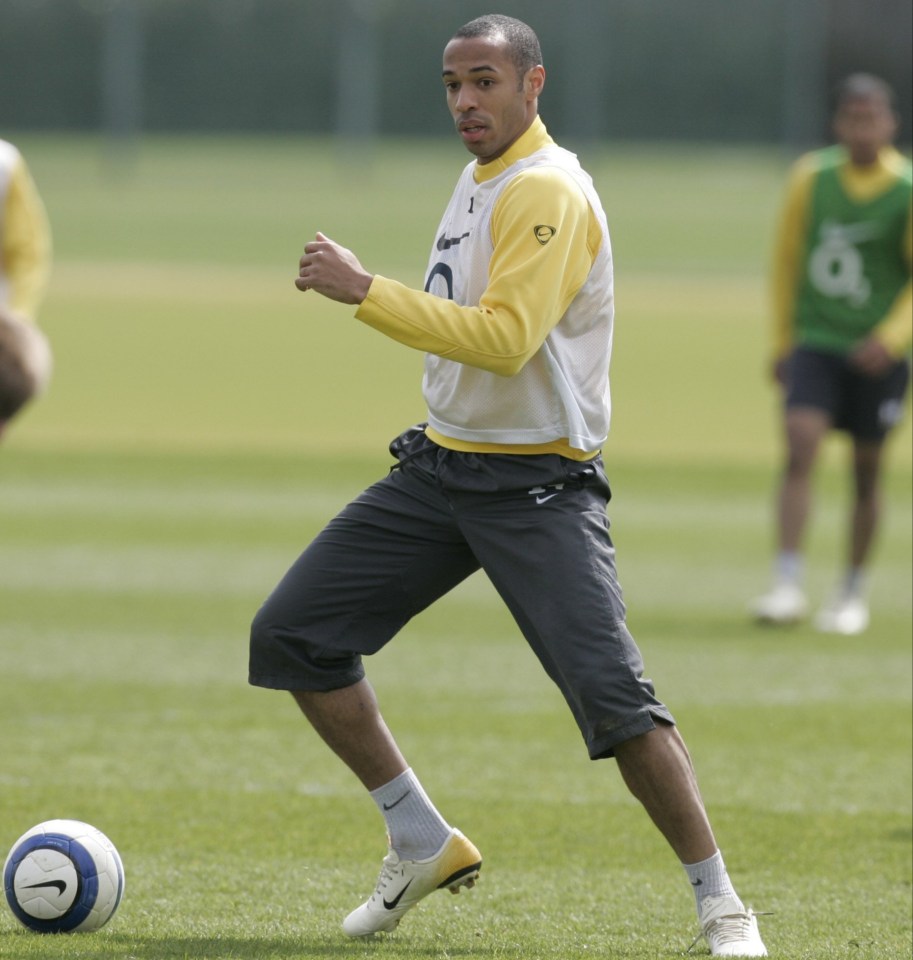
[752, 74, 913, 635]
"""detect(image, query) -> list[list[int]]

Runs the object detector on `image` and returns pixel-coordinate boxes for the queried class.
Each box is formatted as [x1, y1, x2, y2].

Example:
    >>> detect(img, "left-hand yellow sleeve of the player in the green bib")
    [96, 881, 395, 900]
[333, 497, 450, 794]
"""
[771, 156, 817, 360]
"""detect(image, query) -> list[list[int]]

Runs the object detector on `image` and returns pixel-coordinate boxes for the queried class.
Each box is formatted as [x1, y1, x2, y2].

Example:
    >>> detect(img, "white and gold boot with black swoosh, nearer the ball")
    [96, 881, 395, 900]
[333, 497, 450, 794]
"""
[342, 830, 482, 937]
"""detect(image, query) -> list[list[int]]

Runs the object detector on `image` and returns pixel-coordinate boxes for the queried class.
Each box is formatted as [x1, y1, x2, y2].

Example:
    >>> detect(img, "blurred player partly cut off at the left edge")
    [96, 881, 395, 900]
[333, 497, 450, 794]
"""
[0, 140, 51, 436]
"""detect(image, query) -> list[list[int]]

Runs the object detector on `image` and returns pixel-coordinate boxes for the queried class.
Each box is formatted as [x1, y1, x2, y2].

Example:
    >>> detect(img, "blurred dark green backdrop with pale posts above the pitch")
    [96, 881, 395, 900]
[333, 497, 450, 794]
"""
[0, 0, 913, 147]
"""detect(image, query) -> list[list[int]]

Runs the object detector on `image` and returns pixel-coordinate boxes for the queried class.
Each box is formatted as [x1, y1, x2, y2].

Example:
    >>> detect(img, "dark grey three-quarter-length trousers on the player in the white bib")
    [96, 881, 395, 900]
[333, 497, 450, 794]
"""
[249, 427, 674, 759]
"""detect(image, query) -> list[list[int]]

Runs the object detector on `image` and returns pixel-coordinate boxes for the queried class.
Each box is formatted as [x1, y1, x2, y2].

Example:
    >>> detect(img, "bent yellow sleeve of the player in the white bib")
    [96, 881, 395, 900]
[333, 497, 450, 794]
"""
[355, 167, 601, 376]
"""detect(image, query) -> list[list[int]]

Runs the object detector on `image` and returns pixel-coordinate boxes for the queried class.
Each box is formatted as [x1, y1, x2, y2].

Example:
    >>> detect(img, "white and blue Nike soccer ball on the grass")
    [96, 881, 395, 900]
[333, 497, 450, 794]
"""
[3, 820, 124, 933]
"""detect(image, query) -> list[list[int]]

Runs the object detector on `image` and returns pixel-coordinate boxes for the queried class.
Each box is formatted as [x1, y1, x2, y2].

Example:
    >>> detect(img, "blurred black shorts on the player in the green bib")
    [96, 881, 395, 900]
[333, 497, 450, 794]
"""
[786, 347, 910, 440]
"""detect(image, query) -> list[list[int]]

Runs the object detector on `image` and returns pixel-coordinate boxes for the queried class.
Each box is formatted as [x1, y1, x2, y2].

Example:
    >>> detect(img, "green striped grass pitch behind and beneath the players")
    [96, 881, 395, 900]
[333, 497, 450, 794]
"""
[0, 136, 913, 960]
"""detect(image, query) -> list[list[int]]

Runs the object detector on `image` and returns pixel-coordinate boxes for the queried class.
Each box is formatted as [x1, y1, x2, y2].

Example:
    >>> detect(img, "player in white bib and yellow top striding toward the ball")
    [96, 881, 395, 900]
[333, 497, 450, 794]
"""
[250, 15, 766, 957]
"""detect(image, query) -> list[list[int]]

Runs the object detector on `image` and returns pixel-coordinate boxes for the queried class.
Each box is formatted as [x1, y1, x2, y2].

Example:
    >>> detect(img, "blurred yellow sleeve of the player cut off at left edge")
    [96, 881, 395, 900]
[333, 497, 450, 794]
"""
[3, 159, 51, 320]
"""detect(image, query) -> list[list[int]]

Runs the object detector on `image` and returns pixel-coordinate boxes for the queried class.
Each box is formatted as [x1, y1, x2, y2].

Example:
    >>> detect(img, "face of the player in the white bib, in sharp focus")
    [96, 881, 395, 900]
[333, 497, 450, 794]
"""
[443, 37, 545, 163]
